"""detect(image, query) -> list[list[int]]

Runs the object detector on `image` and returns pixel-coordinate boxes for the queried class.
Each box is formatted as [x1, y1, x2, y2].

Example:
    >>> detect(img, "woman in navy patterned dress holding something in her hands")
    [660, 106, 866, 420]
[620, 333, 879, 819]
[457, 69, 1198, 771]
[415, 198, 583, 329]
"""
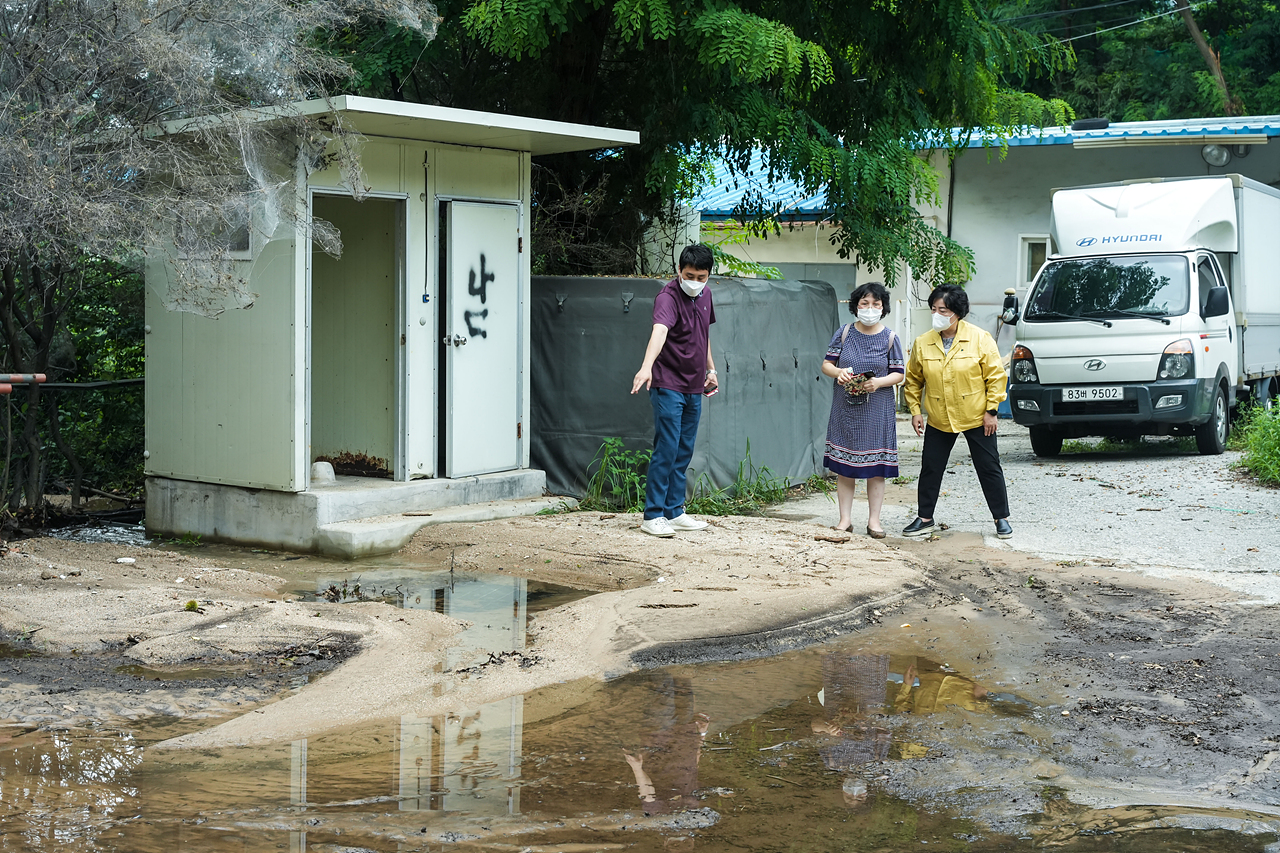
[822, 282, 904, 539]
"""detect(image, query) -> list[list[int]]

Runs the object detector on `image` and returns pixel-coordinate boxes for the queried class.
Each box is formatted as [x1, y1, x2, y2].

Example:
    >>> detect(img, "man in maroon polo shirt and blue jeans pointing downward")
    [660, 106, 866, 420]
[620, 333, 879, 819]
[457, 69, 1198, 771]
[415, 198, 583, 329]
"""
[631, 243, 719, 537]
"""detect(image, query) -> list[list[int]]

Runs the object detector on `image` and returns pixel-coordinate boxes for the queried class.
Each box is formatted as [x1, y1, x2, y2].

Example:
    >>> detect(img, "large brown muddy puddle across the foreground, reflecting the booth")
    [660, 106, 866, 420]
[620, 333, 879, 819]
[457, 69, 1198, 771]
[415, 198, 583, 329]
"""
[0, 630, 1280, 853]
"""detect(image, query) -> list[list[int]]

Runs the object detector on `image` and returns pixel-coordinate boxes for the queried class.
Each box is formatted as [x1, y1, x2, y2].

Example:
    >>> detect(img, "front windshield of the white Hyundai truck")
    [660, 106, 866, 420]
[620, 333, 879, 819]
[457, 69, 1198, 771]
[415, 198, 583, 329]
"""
[1024, 255, 1190, 320]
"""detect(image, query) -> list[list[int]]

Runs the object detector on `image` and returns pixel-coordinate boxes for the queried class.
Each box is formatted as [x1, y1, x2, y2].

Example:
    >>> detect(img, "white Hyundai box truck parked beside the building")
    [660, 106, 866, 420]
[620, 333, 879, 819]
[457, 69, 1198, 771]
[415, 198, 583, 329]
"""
[1002, 174, 1280, 456]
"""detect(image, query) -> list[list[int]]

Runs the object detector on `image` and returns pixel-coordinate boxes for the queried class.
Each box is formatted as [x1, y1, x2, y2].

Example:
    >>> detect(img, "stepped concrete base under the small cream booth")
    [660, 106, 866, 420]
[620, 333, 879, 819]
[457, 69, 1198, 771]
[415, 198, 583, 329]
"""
[146, 470, 563, 560]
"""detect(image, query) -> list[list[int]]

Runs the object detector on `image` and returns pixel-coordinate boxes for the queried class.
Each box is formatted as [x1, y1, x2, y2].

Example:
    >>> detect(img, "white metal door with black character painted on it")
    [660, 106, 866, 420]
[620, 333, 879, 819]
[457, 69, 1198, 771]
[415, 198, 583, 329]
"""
[443, 201, 521, 476]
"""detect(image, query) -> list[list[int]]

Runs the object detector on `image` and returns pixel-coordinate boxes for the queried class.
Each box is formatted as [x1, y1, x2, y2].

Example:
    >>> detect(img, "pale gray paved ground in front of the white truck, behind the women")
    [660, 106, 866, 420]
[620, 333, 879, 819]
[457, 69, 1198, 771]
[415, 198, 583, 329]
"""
[780, 420, 1280, 602]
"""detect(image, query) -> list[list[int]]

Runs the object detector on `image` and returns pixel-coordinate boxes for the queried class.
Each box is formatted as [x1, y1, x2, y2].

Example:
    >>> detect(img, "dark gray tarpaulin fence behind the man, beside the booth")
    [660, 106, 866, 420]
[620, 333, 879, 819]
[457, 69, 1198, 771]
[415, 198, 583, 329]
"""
[530, 277, 842, 496]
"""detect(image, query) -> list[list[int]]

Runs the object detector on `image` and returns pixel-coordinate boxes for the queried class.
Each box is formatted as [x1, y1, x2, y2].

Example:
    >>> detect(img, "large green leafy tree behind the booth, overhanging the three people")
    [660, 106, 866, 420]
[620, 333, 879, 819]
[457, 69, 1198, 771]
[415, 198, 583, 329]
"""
[329, 0, 1069, 283]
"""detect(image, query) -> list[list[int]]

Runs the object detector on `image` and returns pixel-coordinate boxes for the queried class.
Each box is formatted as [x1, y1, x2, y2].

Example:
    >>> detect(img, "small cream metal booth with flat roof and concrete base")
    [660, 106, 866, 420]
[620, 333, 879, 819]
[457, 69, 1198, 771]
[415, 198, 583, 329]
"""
[146, 96, 639, 557]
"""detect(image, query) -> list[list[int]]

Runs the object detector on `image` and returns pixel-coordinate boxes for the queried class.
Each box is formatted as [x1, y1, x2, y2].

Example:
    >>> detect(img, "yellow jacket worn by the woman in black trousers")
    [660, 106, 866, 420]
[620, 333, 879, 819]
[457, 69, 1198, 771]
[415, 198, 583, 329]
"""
[902, 320, 1007, 433]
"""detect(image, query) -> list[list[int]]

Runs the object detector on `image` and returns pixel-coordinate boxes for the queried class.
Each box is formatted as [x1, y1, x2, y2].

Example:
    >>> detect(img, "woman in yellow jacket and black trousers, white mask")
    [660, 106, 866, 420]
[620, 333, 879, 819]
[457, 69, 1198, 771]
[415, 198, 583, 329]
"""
[902, 284, 1014, 539]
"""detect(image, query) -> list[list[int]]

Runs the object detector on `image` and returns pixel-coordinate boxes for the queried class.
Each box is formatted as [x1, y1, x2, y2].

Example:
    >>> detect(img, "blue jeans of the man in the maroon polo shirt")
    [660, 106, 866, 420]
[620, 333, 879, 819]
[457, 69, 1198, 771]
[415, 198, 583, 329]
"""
[644, 388, 703, 519]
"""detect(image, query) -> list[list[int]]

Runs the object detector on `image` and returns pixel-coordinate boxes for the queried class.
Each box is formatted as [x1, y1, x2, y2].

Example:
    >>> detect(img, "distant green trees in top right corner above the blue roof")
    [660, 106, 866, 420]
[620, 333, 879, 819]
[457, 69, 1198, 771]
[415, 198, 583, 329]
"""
[993, 0, 1280, 122]
